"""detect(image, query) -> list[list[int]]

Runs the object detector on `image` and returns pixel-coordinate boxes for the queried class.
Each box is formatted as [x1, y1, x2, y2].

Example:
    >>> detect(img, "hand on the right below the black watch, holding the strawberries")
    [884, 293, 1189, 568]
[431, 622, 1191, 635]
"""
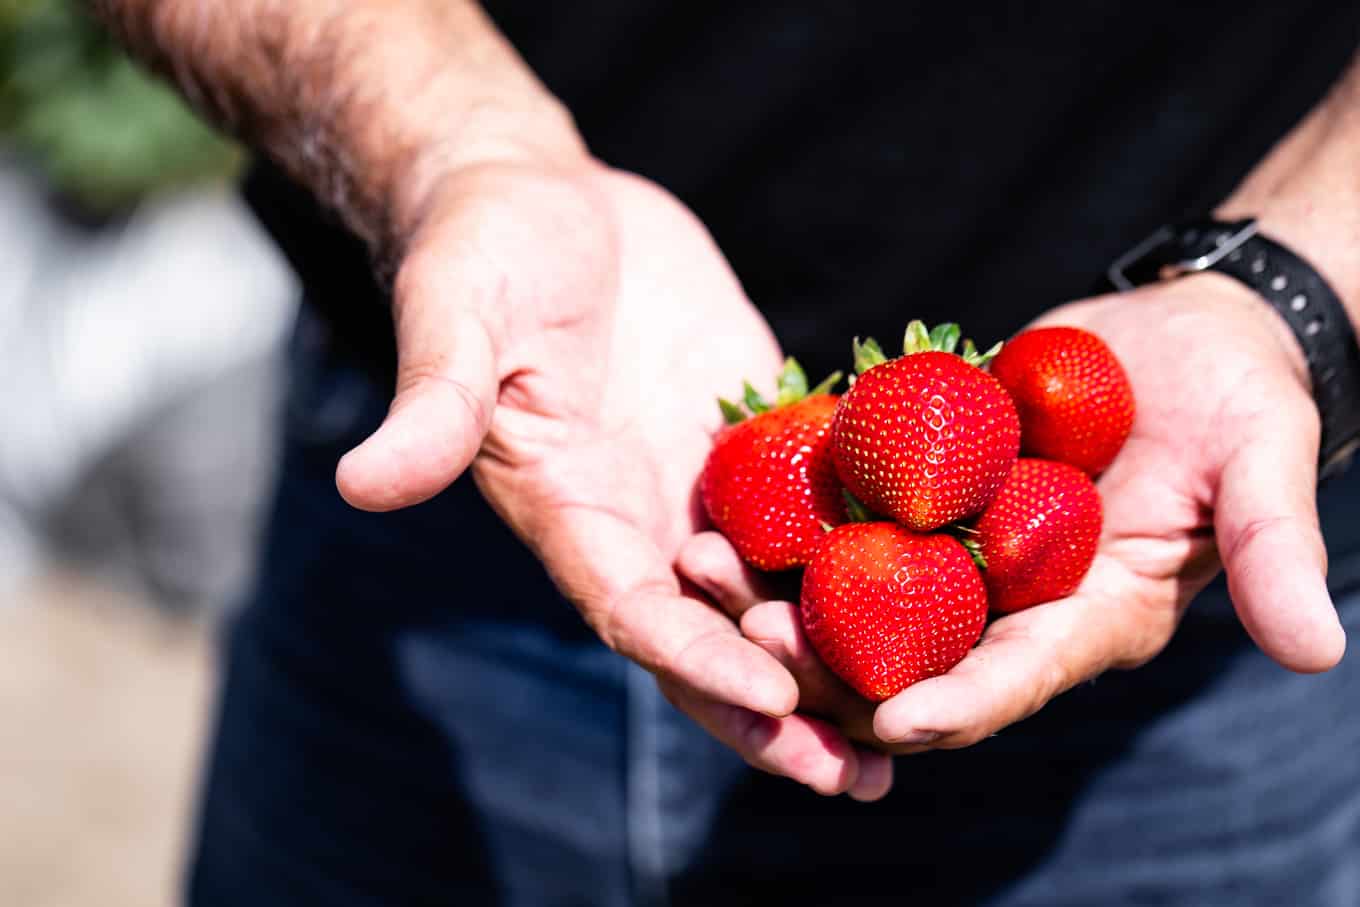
[687, 275, 1345, 752]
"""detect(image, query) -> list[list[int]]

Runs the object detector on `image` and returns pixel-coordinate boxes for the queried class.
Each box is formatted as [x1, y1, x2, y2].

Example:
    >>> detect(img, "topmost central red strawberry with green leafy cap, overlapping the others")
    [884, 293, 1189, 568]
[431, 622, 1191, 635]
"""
[831, 321, 1020, 532]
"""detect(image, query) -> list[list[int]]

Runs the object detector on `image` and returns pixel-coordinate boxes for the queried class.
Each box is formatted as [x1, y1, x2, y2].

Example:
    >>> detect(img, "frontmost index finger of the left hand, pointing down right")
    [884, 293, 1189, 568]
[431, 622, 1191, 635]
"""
[529, 507, 798, 715]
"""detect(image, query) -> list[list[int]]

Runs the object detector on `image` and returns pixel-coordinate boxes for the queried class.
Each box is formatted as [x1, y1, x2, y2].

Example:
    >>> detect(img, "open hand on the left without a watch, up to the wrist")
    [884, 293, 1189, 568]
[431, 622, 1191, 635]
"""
[323, 165, 877, 793]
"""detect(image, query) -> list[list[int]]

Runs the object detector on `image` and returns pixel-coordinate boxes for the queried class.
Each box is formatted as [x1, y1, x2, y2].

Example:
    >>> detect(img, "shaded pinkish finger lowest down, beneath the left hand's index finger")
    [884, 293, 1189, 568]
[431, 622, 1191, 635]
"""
[661, 683, 859, 797]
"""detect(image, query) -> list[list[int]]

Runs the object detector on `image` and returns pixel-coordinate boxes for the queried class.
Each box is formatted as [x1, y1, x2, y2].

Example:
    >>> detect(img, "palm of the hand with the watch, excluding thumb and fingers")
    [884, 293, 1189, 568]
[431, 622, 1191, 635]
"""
[1022, 286, 1315, 652]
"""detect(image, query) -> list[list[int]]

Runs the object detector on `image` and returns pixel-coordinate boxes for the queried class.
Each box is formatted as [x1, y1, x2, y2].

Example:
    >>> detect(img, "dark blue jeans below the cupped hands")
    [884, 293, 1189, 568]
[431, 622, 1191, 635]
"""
[189, 330, 1360, 907]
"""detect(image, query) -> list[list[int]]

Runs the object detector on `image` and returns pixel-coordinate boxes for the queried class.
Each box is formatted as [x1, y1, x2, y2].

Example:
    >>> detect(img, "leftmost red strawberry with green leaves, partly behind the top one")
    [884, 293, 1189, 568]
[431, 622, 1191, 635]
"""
[699, 359, 846, 570]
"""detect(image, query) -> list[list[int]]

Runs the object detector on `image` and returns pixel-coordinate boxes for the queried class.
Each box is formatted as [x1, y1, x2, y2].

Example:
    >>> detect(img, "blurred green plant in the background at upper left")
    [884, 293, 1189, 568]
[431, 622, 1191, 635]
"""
[0, 0, 243, 215]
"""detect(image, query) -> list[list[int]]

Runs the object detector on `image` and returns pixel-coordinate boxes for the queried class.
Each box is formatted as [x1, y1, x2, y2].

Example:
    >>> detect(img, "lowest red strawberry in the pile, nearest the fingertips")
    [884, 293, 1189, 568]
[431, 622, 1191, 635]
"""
[802, 522, 987, 702]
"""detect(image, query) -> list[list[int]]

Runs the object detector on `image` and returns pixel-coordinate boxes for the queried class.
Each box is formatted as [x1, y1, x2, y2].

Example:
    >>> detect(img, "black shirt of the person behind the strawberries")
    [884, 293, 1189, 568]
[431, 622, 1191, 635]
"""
[248, 0, 1360, 383]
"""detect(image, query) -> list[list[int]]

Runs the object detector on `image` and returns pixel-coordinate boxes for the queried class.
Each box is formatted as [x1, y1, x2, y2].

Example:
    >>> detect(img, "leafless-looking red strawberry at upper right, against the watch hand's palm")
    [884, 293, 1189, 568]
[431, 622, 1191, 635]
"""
[991, 328, 1133, 476]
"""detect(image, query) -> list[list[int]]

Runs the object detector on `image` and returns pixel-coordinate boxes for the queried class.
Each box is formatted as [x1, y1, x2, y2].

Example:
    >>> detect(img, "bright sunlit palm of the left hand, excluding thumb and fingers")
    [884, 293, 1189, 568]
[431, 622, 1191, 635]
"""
[473, 168, 779, 617]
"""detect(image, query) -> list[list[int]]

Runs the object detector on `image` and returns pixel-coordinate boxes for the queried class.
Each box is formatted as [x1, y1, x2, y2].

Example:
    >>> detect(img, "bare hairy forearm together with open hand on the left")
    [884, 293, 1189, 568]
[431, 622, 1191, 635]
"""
[95, 0, 888, 794]
